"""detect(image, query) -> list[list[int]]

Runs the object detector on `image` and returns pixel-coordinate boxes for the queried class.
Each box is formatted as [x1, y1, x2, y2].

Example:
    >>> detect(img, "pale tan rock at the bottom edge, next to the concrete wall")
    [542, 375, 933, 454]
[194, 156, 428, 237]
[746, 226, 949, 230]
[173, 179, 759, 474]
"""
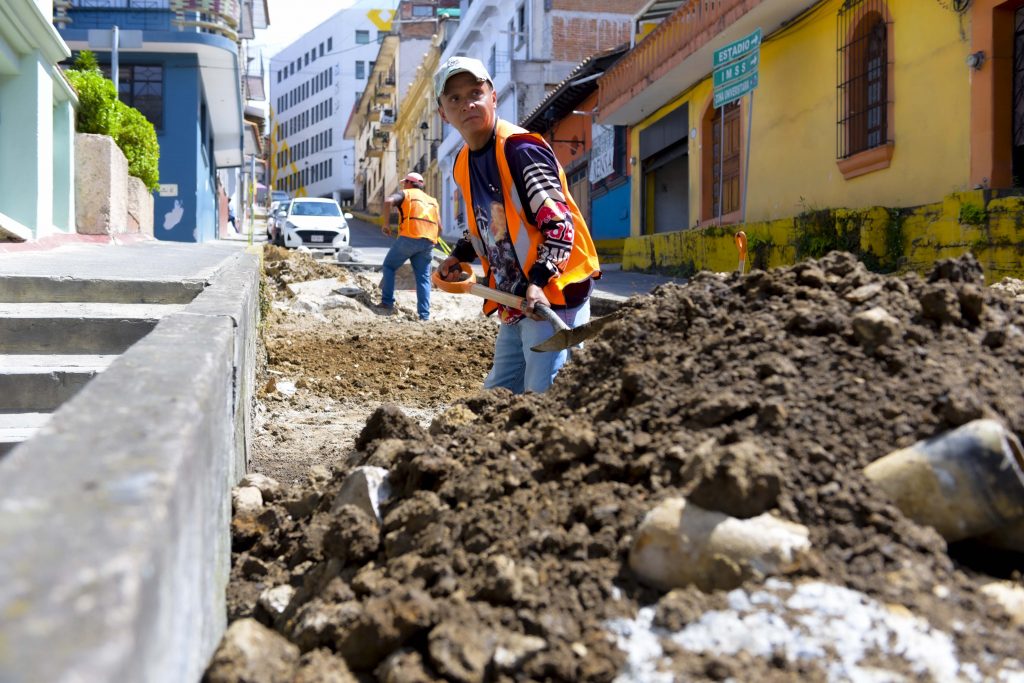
[203, 618, 299, 683]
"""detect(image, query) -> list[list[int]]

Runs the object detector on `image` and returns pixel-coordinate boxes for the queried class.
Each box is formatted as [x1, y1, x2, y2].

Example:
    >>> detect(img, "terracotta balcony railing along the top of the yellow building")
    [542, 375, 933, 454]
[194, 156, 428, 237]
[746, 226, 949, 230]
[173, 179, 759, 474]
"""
[598, 0, 762, 113]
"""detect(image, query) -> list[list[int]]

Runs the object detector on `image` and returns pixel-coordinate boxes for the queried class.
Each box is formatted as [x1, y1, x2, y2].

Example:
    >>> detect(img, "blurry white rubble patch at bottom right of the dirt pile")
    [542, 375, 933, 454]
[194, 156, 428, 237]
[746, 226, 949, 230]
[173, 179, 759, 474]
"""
[605, 579, 1024, 683]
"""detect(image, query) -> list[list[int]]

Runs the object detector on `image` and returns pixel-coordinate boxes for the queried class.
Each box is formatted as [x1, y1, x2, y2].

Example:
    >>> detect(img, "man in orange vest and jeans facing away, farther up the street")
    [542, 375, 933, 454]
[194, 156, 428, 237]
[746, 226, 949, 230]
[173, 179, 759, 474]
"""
[377, 173, 440, 321]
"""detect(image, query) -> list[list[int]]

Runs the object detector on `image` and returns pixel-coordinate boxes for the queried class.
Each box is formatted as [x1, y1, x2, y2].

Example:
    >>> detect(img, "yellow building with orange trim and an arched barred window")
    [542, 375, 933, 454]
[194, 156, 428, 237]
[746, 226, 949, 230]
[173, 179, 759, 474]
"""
[598, 0, 1024, 278]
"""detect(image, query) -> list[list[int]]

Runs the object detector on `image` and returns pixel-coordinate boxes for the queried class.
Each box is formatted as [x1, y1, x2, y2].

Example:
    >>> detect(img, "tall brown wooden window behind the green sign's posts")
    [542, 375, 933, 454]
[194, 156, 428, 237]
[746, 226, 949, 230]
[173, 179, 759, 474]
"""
[700, 102, 742, 221]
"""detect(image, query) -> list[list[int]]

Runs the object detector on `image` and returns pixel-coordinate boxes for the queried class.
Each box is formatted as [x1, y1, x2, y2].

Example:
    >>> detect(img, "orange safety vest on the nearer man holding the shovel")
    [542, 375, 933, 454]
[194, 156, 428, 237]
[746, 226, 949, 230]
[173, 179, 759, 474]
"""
[454, 119, 600, 313]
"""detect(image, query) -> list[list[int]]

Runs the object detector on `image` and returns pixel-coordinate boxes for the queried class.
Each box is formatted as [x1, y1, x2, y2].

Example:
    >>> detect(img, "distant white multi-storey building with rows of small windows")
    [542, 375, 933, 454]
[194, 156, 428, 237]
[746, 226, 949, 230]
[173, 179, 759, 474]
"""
[268, 0, 397, 203]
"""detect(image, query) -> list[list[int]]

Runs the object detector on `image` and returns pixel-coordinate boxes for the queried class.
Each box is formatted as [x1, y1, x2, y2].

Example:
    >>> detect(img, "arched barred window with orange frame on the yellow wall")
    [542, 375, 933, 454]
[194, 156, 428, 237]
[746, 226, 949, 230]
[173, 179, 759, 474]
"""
[836, 0, 893, 178]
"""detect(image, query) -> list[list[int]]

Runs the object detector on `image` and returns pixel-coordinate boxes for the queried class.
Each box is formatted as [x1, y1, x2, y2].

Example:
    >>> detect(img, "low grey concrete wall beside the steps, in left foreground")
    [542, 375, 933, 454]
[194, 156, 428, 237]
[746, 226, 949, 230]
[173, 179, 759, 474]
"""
[0, 254, 258, 683]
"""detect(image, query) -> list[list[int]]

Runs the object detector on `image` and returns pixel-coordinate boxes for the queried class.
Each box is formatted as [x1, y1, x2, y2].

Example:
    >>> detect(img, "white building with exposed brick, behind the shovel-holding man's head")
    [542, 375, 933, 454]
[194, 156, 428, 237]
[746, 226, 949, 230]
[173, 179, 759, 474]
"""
[438, 0, 643, 237]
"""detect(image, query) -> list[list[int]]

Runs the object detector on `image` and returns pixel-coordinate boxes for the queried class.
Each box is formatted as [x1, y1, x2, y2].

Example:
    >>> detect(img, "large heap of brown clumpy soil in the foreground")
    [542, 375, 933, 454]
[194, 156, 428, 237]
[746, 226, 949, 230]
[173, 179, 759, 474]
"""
[208, 253, 1024, 681]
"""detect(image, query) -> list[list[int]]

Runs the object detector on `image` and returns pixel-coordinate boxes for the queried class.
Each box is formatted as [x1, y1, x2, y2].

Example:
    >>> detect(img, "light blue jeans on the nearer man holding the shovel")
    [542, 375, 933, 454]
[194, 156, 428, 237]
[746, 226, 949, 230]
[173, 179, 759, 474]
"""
[483, 299, 590, 393]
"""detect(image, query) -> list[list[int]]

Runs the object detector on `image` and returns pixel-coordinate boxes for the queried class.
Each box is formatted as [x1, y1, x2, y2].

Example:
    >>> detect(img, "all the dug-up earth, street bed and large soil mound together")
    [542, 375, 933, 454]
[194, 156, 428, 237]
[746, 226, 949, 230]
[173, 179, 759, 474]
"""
[207, 248, 1024, 681]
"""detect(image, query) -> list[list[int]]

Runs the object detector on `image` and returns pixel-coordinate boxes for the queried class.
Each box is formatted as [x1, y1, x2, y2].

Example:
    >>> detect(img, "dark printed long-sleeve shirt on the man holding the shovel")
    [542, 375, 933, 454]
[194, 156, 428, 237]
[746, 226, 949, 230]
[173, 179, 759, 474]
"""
[453, 138, 592, 324]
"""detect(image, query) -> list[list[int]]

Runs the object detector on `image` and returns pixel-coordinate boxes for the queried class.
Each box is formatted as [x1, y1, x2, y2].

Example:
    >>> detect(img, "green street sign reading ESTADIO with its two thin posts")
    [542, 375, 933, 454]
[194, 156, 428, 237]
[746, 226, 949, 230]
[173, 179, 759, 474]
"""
[712, 29, 762, 225]
